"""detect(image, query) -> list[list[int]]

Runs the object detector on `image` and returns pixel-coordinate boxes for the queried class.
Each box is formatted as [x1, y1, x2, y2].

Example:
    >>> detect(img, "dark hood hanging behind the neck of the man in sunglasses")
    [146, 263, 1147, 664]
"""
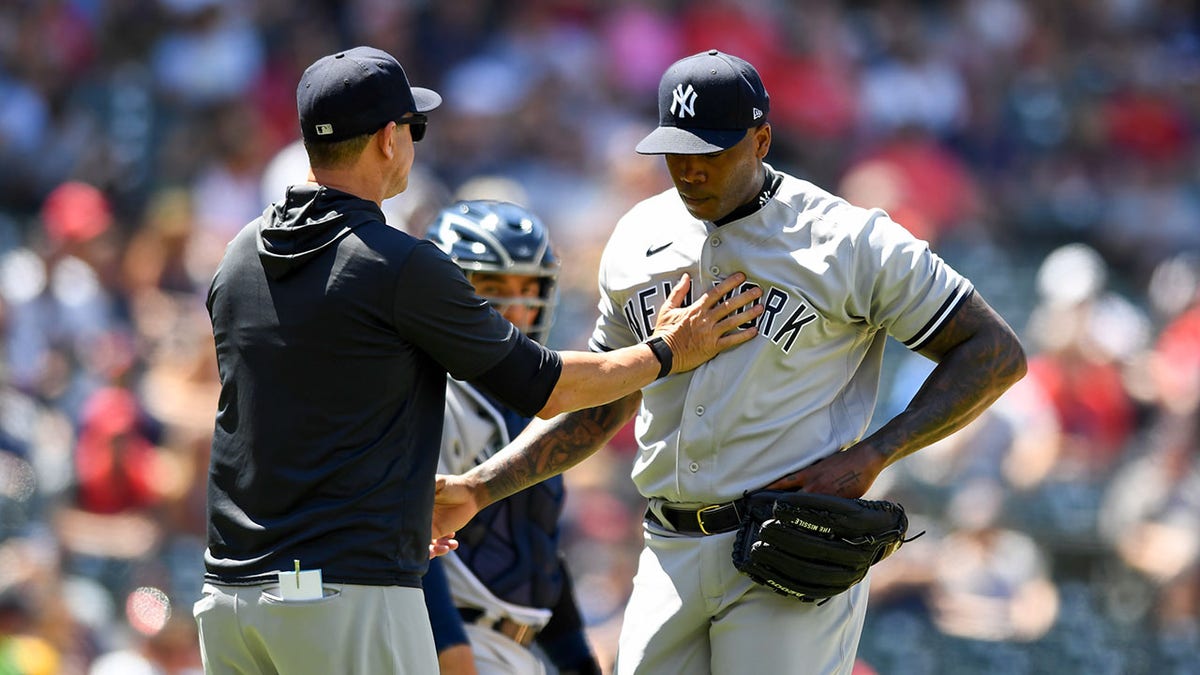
[258, 183, 385, 279]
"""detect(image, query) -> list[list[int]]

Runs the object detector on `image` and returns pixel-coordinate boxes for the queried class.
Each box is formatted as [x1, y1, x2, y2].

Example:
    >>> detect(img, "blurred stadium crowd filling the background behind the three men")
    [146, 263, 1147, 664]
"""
[0, 0, 1200, 675]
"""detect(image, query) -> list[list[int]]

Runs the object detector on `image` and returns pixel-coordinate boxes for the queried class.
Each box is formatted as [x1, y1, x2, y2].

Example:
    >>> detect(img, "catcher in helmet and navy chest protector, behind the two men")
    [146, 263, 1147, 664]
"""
[424, 199, 600, 675]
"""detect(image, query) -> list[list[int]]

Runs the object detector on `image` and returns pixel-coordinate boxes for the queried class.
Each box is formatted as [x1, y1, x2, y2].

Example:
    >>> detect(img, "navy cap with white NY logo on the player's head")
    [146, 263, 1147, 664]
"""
[637, 49, 770, 155]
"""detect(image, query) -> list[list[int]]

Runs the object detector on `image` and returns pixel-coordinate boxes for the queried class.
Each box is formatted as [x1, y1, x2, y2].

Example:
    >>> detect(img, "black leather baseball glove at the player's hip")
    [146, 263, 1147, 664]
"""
[733, 490, 919, 601]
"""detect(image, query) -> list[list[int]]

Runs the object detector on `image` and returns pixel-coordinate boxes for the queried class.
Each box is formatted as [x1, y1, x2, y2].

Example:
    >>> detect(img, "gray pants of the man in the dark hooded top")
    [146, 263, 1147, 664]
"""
[192, 584, 438, 675]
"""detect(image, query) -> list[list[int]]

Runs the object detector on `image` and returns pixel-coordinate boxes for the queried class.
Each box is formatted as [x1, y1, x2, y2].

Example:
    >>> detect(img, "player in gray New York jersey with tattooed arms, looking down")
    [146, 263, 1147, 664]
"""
[433, 49, 1026, 675]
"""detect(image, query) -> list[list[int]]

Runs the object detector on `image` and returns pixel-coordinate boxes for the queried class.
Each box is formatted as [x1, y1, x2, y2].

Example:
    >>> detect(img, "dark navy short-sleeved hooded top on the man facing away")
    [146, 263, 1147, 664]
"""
[205, 184, 562, 586]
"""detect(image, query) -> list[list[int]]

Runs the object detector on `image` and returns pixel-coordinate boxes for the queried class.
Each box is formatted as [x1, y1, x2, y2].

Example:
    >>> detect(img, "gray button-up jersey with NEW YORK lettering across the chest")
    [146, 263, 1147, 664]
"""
[590, 167, 973, 503]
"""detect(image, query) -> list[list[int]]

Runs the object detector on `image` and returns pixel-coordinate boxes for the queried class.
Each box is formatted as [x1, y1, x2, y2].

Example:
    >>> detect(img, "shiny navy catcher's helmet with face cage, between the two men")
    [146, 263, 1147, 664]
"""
[426, 199, 559, 345]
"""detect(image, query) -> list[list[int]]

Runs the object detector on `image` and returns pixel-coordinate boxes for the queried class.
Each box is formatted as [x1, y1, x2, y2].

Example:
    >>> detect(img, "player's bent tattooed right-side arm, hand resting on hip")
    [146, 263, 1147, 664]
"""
[870, 291, 1026, 464]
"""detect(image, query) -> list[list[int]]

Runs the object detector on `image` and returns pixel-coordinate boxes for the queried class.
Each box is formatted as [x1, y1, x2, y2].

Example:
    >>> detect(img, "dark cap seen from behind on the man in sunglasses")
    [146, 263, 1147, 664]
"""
[296, 47, 442, 142]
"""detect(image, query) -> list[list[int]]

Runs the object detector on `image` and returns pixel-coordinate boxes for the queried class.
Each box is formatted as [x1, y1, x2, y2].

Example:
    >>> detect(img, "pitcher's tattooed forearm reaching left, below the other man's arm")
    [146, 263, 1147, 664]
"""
[475, 394, 641, 503]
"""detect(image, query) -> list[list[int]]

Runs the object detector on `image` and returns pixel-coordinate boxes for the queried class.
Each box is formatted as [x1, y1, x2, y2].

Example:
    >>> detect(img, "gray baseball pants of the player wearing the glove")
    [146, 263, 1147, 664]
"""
[616, 525, 868, 675]
